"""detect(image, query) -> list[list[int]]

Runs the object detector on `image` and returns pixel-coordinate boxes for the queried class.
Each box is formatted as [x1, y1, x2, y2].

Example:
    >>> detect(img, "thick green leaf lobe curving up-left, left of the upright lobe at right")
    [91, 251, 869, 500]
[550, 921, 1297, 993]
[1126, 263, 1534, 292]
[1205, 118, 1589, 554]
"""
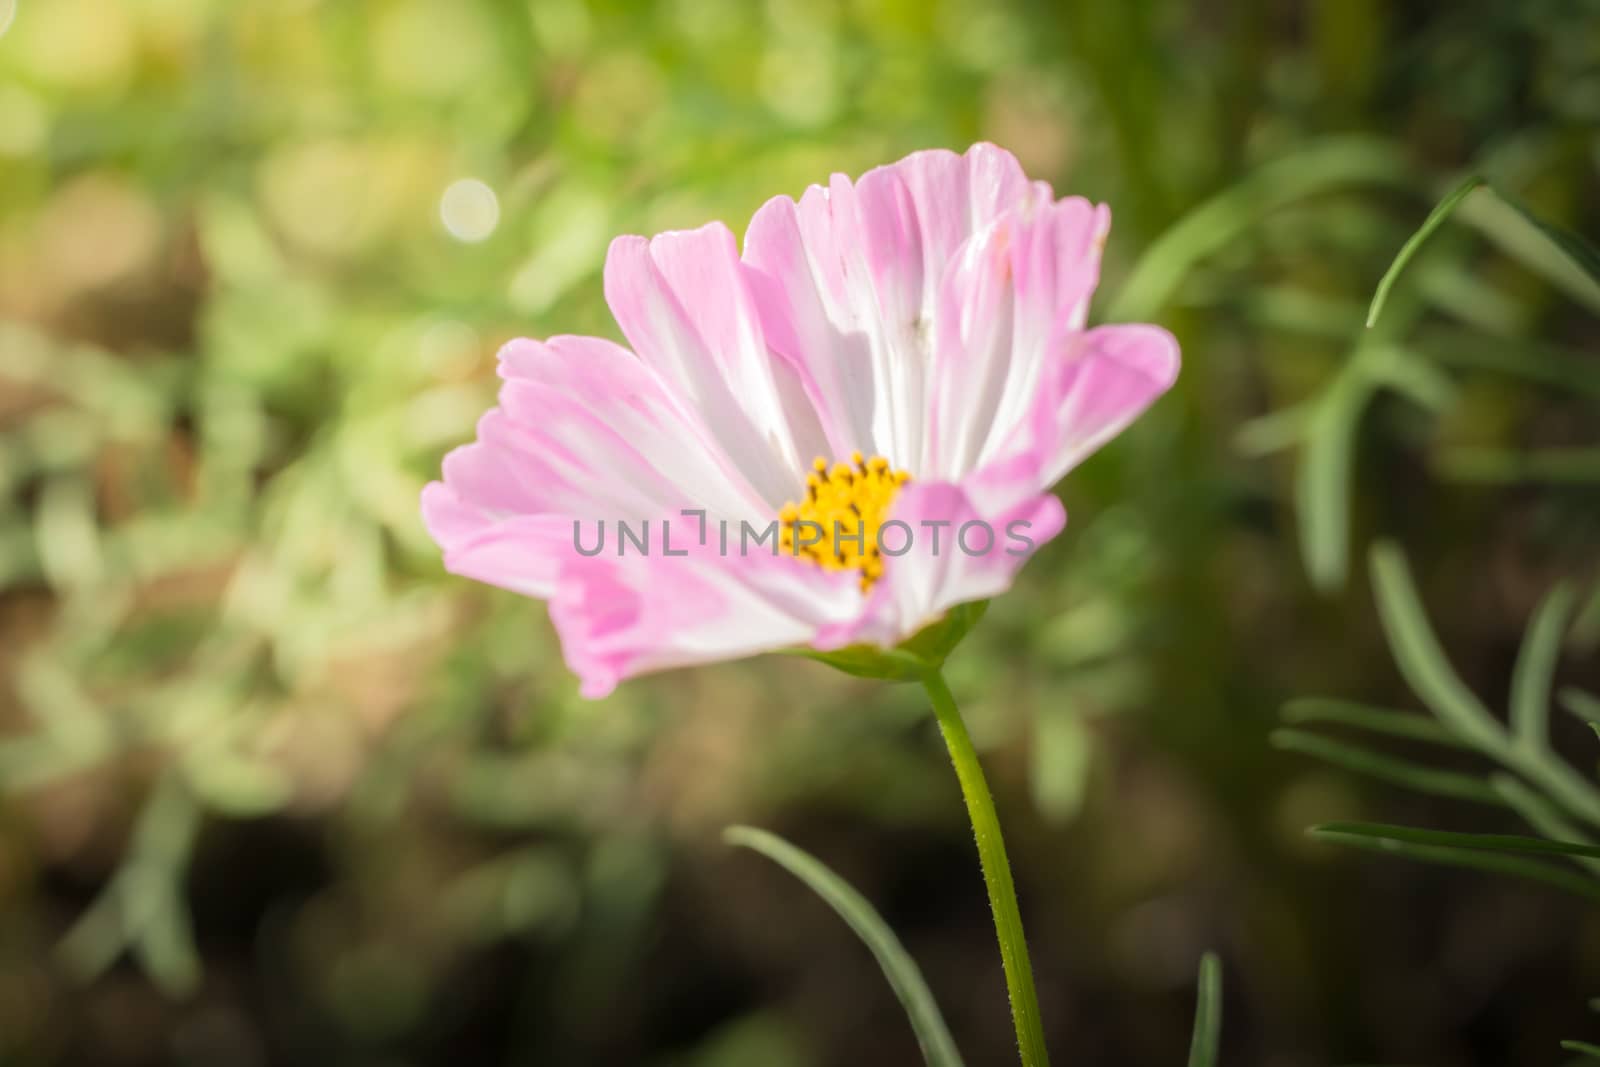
[1371, 541, 1506, 752]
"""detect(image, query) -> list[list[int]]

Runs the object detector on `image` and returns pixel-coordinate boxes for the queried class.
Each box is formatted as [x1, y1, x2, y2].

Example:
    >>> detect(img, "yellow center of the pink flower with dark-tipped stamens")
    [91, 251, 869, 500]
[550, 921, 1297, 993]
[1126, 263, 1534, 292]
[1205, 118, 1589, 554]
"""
[778, 453, 910, 592]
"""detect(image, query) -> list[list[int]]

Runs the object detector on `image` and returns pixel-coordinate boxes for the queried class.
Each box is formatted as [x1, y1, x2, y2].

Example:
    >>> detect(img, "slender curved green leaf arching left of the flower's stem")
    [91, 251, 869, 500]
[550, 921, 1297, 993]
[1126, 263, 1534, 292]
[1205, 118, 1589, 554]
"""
[722, 825, 962, 1067]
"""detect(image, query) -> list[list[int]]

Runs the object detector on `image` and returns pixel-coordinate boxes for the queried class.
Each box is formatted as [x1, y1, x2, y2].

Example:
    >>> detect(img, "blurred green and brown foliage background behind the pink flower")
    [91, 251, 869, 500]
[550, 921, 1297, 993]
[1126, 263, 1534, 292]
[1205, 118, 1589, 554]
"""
[0, 0, 1600, 1067]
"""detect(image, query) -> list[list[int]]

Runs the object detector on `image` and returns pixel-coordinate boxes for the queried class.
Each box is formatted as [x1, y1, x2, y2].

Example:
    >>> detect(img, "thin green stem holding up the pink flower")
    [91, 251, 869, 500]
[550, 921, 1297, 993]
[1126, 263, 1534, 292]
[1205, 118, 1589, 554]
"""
[922, 669, 1050, 1067]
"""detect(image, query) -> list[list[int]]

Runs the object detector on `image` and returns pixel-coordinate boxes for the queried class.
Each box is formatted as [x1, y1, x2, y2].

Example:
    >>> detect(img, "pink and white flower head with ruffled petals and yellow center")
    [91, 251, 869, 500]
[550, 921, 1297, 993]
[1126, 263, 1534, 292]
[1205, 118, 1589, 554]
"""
[422, 144, 1178, 697]
